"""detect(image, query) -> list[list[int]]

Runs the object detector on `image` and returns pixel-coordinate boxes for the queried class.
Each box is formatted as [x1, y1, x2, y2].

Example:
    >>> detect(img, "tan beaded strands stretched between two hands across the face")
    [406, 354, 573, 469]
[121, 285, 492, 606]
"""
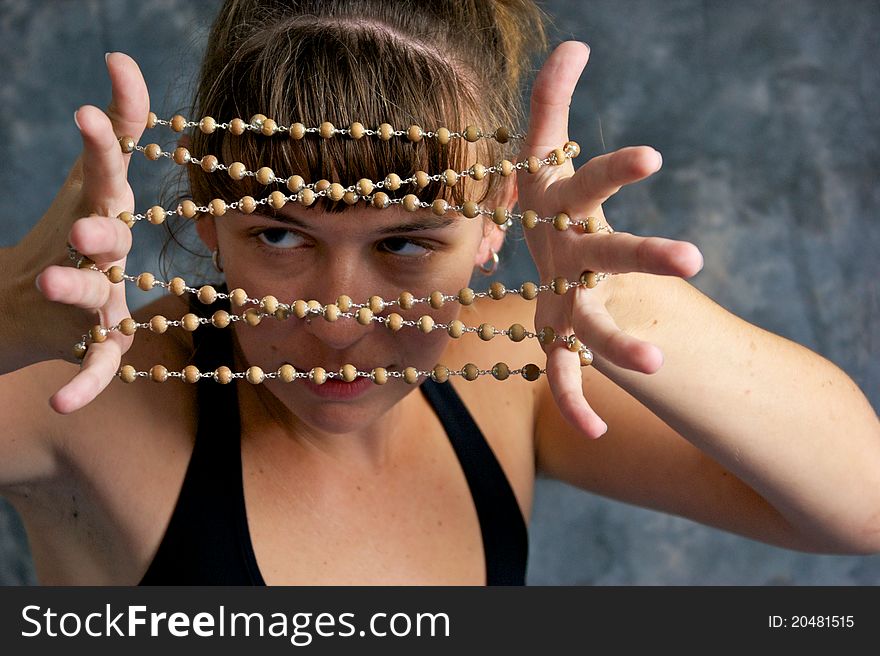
[68, 112, 612, 385]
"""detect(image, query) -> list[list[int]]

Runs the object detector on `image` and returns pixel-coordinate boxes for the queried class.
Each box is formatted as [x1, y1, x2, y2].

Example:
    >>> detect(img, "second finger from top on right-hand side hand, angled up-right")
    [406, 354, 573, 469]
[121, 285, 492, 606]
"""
[553, 146, 663, 214]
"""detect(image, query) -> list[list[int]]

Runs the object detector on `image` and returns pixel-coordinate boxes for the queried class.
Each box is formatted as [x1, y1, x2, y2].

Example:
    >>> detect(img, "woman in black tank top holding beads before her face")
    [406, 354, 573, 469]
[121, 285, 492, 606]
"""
[0, 2, 880, 584]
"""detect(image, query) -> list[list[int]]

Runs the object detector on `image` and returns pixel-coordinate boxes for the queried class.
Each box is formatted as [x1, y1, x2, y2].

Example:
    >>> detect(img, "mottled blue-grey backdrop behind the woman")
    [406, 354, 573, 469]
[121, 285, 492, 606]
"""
[0, 0, 880, 585]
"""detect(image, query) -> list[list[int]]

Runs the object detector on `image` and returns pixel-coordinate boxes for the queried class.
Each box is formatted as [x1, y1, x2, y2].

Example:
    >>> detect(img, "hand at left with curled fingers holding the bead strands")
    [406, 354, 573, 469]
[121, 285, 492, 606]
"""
[27, 53, 149, 413]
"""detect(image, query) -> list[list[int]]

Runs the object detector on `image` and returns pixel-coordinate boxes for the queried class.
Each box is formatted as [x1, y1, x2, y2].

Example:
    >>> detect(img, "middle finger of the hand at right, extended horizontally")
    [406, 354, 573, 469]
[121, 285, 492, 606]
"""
[580, 232, 703, 278]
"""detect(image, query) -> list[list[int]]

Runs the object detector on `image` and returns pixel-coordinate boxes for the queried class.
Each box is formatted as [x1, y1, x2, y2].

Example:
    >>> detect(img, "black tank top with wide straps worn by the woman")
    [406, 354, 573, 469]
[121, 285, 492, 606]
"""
[140, 290, 528, 585]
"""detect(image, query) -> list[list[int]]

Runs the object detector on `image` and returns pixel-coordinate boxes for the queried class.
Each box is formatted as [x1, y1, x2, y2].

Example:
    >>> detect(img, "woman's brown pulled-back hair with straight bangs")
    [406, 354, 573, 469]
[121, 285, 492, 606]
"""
[160, 0, 546, 276]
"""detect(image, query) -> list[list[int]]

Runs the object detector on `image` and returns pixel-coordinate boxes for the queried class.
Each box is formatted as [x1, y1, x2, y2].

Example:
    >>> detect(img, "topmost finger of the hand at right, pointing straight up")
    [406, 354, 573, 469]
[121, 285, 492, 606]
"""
[524, 41, 590, 151]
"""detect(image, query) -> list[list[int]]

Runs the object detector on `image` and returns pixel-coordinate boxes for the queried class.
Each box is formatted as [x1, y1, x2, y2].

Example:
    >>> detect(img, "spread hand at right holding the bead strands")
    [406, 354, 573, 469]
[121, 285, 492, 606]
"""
[517, 41, 703, 437]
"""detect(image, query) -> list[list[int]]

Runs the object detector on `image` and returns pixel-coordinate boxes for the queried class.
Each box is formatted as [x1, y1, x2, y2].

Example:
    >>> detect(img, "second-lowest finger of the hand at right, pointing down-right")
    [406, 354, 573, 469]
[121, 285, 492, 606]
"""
[572, 298, 663, 374]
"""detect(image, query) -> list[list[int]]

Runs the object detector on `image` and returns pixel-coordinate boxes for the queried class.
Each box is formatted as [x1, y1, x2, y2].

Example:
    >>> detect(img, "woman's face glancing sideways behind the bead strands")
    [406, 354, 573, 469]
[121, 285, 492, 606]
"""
[199, 203, 498, 433]
